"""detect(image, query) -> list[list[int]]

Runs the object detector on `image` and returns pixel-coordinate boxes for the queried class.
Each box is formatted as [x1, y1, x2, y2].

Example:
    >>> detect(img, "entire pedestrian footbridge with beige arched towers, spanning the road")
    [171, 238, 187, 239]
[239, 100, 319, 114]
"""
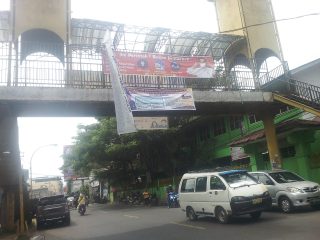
[0, 1, 320, 233]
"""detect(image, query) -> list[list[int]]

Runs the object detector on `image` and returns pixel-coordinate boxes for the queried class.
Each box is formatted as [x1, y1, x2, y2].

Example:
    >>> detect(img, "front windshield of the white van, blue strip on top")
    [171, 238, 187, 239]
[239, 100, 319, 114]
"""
[220, 172, 258, 188]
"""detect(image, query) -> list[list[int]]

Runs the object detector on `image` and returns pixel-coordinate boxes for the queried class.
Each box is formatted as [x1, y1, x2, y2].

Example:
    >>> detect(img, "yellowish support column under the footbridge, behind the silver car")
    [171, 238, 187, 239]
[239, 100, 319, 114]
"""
[262, 114, 281, 169]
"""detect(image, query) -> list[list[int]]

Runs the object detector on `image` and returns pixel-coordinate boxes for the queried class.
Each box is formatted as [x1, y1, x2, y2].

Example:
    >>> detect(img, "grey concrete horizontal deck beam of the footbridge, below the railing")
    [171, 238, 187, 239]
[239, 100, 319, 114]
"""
[0, 87, 280, 117]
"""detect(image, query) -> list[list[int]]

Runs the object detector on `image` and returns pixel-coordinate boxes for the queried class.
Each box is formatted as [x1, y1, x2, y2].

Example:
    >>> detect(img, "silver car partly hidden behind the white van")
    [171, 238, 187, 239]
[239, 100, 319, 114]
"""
[250, 170, 320, 213]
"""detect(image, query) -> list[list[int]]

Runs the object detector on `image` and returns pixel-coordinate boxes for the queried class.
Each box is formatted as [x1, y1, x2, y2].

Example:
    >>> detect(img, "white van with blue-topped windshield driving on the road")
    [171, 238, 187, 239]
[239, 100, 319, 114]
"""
[179, 170, 271, 223]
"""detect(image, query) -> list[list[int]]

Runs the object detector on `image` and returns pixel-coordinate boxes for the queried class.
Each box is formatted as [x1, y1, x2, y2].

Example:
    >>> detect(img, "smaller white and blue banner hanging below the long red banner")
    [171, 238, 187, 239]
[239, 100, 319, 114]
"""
[125, 87, 196, 111]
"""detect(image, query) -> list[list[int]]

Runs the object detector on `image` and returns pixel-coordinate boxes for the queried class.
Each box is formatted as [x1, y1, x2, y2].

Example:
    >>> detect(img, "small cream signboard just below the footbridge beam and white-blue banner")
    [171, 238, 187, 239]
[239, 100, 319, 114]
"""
[134, 117, 168, 130]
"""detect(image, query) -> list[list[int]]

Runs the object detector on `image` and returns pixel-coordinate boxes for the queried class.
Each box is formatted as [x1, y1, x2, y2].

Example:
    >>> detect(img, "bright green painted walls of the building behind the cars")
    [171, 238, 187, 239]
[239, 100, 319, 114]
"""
[192, 109, 320, 183]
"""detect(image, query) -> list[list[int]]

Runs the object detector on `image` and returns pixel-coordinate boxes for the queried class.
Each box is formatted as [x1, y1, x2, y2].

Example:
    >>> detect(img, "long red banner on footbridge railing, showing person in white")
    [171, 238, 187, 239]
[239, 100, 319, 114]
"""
[103, 51, 214, 78]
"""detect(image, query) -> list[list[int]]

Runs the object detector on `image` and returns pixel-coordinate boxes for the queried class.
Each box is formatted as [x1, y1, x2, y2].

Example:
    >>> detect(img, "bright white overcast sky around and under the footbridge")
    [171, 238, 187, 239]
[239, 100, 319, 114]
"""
[0, 0, 320, 176]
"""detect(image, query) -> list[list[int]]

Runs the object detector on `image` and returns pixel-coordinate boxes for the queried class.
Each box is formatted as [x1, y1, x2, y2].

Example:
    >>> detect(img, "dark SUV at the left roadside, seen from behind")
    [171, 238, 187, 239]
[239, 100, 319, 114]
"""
[36, 195, 70, 228]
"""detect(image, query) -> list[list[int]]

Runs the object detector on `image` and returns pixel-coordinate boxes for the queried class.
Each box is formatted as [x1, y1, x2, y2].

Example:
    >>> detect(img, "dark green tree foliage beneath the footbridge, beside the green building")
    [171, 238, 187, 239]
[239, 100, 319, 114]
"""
[62, 117, 200, 188]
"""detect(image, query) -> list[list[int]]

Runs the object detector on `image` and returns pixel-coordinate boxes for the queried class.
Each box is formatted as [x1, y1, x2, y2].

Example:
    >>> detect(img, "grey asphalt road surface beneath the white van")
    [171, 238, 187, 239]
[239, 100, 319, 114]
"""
[38, 205, 320, 240]
